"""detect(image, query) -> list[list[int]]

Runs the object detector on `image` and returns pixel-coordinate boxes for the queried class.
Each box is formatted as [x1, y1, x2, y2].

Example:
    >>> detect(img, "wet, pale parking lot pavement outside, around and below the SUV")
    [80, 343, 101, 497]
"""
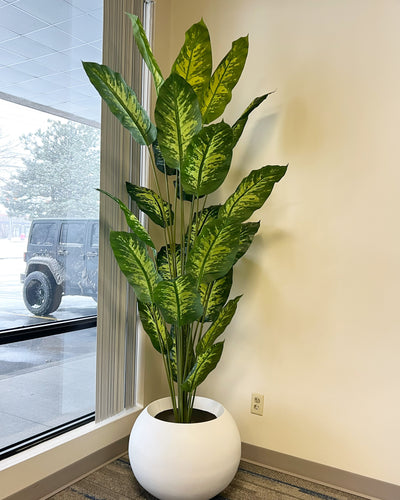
[0, 239, 97, 449]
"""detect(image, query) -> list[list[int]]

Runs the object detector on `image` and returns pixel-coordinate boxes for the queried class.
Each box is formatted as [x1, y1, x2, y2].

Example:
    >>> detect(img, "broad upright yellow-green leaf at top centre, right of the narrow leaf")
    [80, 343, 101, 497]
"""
[172, 20, 212, 99]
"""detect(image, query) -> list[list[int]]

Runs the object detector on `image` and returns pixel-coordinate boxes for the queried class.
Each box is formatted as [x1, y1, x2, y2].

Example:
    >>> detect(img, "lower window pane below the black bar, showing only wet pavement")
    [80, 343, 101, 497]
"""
[0, 328, 96, 450]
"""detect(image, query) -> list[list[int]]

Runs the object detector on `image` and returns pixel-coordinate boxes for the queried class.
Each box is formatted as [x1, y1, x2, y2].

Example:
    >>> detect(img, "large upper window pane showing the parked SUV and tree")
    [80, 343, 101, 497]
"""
[0, 0, 102, 331]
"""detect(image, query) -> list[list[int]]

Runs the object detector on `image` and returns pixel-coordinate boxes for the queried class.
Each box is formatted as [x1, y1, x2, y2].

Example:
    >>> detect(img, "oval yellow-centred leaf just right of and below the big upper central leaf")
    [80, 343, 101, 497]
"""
[181, 122, 233, 196]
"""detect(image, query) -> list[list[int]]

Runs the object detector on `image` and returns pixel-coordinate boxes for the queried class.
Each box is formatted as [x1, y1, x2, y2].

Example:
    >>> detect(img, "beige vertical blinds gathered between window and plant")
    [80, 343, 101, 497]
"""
[96, 0, 151, 421]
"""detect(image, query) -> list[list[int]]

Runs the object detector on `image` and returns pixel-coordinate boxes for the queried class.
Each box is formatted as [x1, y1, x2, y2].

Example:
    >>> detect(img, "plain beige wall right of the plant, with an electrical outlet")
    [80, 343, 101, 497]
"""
[155, 0, 400, 484]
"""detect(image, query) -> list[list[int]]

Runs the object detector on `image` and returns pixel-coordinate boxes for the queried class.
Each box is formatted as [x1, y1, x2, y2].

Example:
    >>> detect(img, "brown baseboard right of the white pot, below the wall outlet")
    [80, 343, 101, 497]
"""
[242, 443, 400, 500]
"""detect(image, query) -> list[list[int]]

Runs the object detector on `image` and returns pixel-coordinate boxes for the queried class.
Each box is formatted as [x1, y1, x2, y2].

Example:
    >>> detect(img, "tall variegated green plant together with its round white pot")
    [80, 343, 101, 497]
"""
[83, 14, 287, 500]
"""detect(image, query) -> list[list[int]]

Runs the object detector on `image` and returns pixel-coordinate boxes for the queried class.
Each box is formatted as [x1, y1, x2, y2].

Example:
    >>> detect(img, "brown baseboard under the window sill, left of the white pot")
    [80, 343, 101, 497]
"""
[4, 436, 129, 500]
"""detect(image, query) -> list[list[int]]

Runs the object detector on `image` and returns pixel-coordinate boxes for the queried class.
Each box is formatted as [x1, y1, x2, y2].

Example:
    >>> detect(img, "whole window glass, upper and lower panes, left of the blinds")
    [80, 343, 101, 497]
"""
[0, 0, 103, 456]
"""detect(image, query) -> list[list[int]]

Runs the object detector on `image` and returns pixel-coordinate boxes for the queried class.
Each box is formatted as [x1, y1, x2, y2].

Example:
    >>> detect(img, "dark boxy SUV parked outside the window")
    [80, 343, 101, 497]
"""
[21, 219, 99, 316]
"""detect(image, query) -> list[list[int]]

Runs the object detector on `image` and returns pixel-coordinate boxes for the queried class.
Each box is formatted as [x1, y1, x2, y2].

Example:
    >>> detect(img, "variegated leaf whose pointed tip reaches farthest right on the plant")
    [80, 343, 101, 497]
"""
[219, 165, 287, 222]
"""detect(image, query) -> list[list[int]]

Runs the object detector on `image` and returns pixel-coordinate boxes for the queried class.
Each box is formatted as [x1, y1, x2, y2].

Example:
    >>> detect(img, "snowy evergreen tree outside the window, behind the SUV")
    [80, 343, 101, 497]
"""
[1, 120, 100, 219]
